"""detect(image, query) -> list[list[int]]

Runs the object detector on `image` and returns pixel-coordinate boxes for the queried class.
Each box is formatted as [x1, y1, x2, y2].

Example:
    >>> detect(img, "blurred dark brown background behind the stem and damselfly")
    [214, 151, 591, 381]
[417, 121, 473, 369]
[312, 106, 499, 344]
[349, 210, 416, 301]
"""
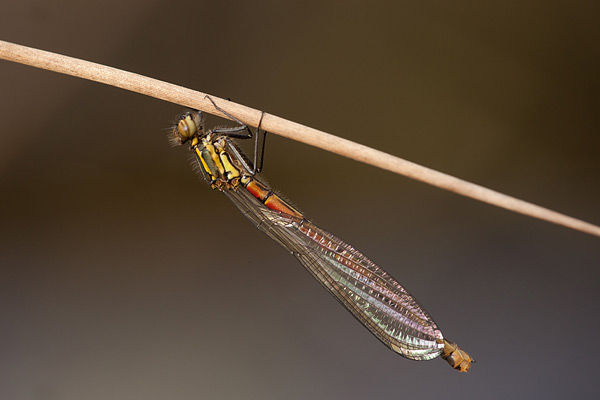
[0, 0, 600, 400]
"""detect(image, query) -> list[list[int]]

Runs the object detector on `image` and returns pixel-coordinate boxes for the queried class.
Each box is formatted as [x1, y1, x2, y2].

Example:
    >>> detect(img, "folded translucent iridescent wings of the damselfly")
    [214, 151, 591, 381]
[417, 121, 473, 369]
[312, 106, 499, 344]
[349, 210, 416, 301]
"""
[223, 187, 444, 360]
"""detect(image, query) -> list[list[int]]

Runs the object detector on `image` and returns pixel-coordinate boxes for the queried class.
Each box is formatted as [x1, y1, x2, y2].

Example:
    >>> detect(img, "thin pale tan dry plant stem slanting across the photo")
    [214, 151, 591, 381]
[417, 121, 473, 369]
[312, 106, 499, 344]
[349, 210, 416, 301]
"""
[0, 41, 600, 236]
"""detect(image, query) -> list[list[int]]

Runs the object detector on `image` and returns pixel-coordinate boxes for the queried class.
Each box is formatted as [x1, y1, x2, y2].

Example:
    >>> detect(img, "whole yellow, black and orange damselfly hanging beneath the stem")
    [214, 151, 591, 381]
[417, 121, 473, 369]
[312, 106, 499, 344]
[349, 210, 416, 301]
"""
[171, 98, 473, 372]
